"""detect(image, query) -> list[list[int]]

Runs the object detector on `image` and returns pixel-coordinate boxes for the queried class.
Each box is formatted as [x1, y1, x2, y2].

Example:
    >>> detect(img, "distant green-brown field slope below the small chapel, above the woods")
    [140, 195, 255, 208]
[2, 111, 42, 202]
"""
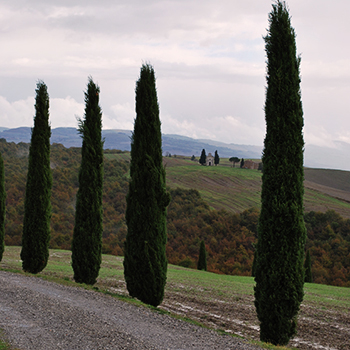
[108, 153, 350, 218]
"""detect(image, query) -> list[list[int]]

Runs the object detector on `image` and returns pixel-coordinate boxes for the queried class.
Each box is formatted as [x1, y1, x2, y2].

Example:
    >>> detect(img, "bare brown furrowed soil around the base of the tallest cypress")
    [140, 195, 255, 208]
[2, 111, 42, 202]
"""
[160, 292, 350, 350]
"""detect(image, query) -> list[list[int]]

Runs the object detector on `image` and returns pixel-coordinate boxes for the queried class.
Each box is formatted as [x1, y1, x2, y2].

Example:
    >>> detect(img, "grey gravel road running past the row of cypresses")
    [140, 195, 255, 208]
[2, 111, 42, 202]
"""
[0, 271, 258, 350]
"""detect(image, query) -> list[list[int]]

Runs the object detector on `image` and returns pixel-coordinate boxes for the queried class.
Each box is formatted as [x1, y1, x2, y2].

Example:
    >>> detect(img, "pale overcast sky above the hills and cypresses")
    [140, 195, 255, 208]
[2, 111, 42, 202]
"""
[0, 0, 350, 146]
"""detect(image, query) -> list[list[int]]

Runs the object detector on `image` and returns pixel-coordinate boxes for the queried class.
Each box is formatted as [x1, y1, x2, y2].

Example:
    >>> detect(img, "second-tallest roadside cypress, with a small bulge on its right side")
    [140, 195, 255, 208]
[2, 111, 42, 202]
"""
[124, 64, 170, 306]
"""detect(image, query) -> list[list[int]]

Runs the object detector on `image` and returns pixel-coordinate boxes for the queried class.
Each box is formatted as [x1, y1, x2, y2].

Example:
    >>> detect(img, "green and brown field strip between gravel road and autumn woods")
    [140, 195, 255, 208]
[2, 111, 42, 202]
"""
[0, 246, 350, 350]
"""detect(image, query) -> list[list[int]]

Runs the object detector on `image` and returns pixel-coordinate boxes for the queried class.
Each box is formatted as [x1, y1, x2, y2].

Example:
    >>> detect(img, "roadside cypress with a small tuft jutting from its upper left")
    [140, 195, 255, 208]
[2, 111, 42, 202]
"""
[72, 77, 103, 284]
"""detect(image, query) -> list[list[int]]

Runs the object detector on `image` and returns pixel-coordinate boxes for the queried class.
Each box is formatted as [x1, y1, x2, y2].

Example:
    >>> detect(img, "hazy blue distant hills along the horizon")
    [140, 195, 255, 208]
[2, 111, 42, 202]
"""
[0, 127, 350, 170]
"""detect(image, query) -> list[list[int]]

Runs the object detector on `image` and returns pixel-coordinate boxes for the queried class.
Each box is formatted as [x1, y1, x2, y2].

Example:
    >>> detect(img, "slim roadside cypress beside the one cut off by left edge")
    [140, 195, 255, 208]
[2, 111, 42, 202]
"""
[21, 81, 52, 273]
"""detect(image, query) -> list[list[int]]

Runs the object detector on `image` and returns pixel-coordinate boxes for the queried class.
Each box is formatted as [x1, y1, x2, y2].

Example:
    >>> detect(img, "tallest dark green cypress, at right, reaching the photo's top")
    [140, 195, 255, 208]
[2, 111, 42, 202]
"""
[255, 1, 306, 345]
